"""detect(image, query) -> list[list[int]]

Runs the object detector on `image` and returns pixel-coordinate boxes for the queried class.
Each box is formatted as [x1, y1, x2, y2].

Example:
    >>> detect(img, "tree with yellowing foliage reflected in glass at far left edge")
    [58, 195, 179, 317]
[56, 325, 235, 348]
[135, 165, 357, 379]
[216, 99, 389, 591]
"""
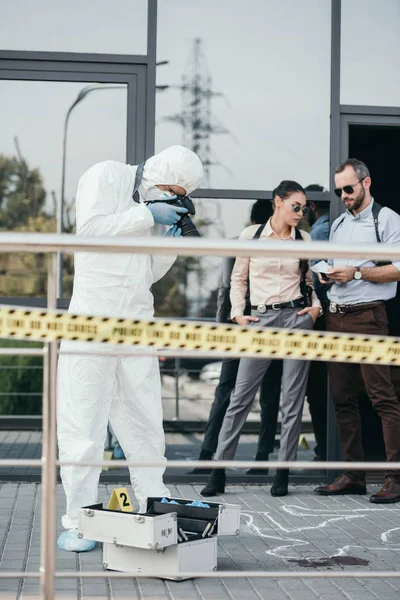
[0, 154, 72, 415]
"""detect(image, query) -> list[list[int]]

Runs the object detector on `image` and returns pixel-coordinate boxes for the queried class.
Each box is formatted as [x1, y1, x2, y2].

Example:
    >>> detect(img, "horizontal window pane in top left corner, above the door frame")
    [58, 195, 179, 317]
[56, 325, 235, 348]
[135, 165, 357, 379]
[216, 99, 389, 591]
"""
[0, 0, 147, 54]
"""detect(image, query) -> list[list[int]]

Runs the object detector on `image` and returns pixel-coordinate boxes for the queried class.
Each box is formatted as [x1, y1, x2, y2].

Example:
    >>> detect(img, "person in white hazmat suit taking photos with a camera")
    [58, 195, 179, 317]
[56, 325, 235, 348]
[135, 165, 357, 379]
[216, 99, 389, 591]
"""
[57, 146, 203, 552]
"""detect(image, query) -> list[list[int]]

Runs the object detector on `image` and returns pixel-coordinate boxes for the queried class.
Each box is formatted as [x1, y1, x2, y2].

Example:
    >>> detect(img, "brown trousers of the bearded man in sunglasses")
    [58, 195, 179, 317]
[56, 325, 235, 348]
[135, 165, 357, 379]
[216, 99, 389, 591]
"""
[327, 303, 400, 481]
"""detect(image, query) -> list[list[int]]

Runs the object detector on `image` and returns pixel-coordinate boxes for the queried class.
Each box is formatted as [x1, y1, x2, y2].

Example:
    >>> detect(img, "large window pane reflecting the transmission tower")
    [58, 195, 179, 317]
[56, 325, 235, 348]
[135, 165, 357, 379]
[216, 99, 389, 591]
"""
[156, 0, 331, 190]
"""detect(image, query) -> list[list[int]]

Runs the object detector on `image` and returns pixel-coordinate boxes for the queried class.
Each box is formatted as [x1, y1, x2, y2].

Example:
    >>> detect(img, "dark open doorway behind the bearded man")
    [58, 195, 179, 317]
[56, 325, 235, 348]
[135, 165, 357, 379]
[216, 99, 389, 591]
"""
[348, 123, 400, 460]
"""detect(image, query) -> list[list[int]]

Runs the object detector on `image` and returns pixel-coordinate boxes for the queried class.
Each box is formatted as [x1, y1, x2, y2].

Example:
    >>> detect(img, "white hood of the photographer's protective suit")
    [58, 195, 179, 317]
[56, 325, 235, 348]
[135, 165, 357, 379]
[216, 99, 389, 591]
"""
[139, 146, 203, 198]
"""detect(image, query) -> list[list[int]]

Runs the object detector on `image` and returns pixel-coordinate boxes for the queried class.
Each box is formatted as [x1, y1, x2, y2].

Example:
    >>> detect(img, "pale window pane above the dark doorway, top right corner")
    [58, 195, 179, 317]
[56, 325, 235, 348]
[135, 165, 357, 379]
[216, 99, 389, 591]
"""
[340, 0, 400, 106]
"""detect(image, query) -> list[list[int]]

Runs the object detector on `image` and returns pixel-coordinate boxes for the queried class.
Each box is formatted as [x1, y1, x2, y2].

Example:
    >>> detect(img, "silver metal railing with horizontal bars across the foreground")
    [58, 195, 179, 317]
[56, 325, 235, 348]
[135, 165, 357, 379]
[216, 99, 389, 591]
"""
[0, 233, 400, 600]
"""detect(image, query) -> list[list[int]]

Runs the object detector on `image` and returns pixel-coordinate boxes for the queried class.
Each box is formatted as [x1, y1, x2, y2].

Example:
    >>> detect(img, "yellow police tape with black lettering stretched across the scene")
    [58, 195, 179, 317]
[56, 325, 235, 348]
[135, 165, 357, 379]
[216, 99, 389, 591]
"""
[0, 306, 400, 365]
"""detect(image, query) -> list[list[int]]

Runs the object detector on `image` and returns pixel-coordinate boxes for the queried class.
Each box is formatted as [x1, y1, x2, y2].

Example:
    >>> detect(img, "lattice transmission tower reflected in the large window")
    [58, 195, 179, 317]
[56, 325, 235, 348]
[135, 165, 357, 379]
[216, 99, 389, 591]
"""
[164, 38, 229, 187]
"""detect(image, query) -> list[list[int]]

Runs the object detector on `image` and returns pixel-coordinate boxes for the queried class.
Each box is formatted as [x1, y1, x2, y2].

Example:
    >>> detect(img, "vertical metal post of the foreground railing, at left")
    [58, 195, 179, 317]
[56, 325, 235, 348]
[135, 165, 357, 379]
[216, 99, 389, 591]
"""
[40, 253, 58, 600]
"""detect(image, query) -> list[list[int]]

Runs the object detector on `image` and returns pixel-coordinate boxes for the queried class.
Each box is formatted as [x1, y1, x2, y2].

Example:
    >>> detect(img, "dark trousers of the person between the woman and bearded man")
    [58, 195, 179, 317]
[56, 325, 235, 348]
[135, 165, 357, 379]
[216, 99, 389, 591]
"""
[306, 314, 328, 460]
